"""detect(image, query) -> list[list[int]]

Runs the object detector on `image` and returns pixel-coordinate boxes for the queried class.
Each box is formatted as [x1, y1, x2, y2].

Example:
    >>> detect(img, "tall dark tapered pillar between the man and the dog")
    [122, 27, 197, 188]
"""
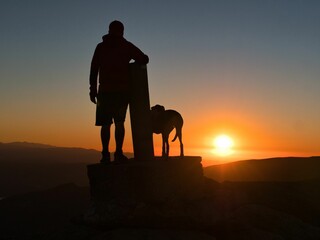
[129, 63, 154, 161]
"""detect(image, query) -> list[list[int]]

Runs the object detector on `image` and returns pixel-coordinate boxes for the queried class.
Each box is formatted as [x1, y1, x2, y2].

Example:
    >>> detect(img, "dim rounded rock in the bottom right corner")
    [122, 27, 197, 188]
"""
[215, 204, 320, 240]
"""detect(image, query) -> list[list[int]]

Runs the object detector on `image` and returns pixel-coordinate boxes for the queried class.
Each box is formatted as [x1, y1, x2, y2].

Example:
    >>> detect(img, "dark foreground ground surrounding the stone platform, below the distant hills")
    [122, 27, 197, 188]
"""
[0, 179, 320, 240]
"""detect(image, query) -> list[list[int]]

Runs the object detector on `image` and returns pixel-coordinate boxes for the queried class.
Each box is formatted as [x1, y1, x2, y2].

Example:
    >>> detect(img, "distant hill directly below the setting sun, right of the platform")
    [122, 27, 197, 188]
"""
[204, 157, 320, 182]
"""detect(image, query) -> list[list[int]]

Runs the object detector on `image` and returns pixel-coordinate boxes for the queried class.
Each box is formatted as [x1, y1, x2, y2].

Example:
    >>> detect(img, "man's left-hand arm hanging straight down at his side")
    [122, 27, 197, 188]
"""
[89, 46, 100, 104]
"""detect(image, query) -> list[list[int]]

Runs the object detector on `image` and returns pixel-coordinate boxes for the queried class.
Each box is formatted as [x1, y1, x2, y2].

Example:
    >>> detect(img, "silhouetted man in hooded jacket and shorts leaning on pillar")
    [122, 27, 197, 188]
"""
[90, 21, 149, 163]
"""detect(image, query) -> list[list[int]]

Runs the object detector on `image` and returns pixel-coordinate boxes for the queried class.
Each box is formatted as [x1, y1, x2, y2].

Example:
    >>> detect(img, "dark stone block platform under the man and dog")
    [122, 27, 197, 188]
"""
[84, 157, 209, 227]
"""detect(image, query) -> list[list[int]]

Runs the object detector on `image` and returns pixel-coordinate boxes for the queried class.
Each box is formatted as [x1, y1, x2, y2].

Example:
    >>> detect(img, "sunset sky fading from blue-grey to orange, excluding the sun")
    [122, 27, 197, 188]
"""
[0, 0, 320, 163]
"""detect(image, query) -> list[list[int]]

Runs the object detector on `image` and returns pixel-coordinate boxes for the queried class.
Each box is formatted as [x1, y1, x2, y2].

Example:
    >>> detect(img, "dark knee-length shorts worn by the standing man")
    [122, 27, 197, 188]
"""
[96, 92, 129, 126]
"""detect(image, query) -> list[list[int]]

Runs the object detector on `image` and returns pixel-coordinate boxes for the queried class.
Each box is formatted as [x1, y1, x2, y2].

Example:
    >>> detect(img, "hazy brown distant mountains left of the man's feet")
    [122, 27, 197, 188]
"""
[0, 142, 132, 197]
